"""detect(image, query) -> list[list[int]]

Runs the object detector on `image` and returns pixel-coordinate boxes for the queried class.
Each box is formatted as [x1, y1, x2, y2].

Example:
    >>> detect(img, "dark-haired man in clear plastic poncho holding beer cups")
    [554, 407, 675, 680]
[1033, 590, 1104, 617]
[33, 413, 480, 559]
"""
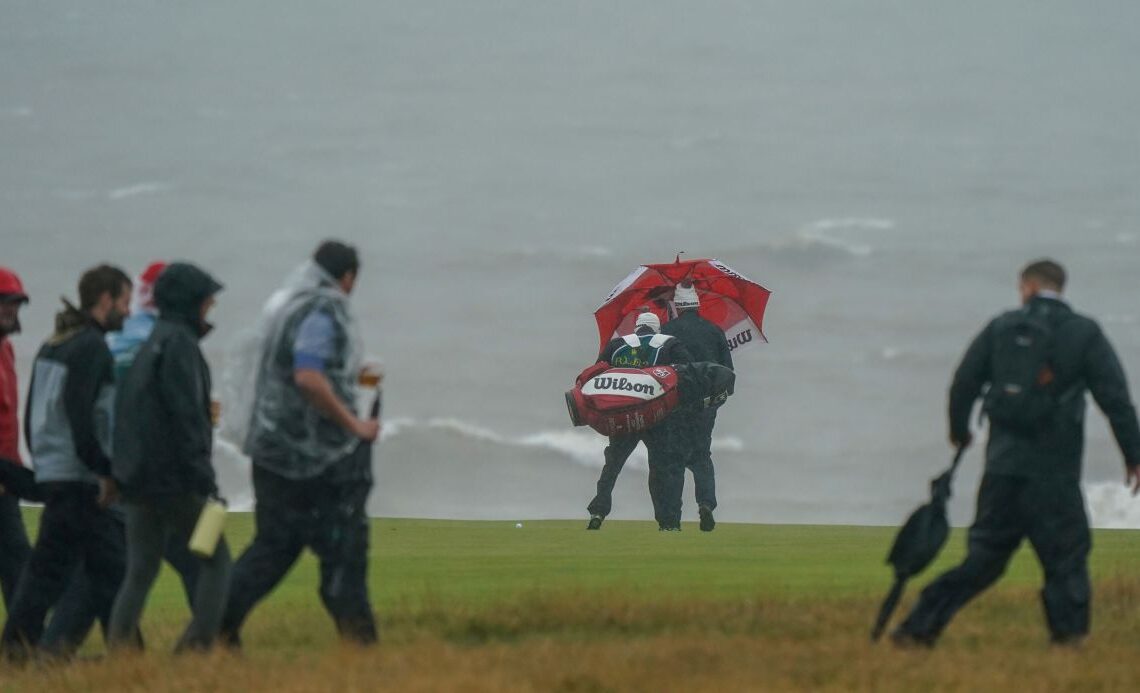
[222, 240, 380, 646]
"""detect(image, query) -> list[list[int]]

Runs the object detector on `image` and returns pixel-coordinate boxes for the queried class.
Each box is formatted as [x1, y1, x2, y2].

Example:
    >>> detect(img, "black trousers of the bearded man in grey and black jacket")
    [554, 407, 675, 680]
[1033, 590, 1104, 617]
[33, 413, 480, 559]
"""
[0, 482, 127, 659]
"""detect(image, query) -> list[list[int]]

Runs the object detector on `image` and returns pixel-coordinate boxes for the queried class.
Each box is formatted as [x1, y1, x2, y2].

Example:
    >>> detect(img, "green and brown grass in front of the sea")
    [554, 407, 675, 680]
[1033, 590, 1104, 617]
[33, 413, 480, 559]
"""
[0, 514, 1140, 692]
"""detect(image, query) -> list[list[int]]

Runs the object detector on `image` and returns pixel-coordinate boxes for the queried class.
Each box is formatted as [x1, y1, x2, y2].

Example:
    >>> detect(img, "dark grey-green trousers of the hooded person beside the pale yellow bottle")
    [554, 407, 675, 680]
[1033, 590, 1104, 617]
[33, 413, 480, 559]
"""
[107, 494, 230, 652]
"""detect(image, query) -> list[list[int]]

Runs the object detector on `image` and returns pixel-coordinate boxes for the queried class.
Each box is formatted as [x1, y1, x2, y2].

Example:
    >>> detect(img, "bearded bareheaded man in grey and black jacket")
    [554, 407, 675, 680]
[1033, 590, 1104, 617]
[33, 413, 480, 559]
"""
[0, 264, 131, 660]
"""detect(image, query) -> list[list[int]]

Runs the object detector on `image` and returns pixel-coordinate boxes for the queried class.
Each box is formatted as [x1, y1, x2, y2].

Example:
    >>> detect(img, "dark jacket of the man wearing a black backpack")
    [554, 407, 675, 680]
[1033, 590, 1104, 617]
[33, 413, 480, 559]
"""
[950, 296, 1140, 479]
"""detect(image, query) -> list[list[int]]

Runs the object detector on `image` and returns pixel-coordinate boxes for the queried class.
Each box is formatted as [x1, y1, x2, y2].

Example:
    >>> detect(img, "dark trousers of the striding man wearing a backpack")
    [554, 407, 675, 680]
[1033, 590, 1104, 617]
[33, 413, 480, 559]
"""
[899, 474, 1092, 642]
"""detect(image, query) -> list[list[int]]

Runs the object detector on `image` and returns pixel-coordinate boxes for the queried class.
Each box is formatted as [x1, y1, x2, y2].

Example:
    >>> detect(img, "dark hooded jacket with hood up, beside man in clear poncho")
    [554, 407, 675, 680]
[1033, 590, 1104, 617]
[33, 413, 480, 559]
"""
[112, 262, 221, 500]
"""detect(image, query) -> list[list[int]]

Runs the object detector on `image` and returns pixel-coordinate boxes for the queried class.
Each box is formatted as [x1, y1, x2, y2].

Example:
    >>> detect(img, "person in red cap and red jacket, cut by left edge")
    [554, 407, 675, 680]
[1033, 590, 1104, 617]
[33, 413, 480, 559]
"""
[0, 267, 32, 609]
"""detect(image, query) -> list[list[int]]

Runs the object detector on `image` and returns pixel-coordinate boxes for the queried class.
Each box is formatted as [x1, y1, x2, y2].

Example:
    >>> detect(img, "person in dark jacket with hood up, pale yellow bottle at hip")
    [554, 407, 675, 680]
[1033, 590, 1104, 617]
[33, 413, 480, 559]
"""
[108, 262, 230, 651]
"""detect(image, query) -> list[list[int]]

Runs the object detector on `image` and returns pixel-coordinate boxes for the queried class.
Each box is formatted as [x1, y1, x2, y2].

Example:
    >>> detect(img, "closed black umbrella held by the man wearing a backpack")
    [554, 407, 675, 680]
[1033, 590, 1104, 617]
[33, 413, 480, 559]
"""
[871, 447, 966, 641]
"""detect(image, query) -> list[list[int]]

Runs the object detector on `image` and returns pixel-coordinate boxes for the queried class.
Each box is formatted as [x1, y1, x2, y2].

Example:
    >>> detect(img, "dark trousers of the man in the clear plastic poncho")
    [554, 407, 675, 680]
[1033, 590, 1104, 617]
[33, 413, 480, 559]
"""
[221, 445, 377, 644]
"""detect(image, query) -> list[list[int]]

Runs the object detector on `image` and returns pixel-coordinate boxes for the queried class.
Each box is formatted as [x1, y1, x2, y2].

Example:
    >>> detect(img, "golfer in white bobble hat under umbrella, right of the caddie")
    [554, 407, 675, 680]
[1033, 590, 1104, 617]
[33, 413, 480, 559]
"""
[661, 283, 732, 532]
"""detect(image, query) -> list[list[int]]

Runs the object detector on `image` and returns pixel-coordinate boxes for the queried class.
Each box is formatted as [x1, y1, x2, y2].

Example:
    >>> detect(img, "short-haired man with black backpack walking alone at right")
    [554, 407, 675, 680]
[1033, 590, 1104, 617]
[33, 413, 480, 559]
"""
[893, 260, 1140, 646]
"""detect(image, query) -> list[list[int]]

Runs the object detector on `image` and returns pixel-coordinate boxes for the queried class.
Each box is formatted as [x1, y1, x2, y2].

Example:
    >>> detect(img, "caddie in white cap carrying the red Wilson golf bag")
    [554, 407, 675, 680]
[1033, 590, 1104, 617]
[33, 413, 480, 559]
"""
[586, 312, 692, 531]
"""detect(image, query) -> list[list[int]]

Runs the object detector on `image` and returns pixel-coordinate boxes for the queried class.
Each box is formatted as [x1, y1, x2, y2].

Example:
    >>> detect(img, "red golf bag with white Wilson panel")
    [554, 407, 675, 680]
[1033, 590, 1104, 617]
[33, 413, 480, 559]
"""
[567, 361, 681, 435]
